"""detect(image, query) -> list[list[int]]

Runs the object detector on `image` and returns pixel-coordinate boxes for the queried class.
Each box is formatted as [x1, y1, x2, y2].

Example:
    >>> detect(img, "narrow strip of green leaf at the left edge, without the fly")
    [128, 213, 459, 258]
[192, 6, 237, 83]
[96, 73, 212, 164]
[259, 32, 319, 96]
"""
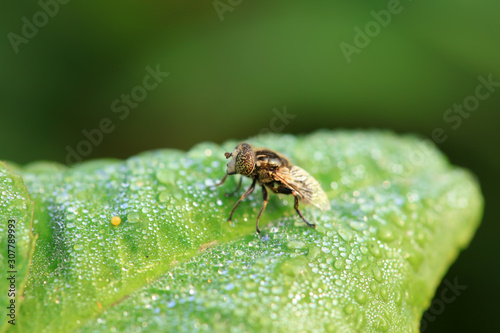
[0, 162, 36, 332]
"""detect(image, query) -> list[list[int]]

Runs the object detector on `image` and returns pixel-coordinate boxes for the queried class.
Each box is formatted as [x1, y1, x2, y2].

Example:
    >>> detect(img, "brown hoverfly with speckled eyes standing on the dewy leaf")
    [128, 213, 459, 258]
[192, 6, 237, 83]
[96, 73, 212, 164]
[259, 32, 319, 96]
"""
[216, 143, 330, 233]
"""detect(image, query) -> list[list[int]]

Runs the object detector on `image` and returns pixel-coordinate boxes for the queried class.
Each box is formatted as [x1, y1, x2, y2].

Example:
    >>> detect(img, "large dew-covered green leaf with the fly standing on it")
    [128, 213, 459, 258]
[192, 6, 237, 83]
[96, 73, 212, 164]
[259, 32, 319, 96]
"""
[2, 131, 483, 332]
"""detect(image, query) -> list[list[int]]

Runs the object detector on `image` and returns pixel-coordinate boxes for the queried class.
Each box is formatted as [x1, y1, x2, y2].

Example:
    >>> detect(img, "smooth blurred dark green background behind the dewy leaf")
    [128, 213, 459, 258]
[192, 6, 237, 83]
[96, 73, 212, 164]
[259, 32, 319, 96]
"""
[0, 0, 500, 332]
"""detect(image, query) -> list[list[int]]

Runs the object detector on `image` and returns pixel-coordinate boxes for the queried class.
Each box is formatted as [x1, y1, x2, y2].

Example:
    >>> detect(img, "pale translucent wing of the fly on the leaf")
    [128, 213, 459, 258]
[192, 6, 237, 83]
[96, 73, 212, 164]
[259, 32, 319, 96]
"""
[276, 166, 330, 210]
